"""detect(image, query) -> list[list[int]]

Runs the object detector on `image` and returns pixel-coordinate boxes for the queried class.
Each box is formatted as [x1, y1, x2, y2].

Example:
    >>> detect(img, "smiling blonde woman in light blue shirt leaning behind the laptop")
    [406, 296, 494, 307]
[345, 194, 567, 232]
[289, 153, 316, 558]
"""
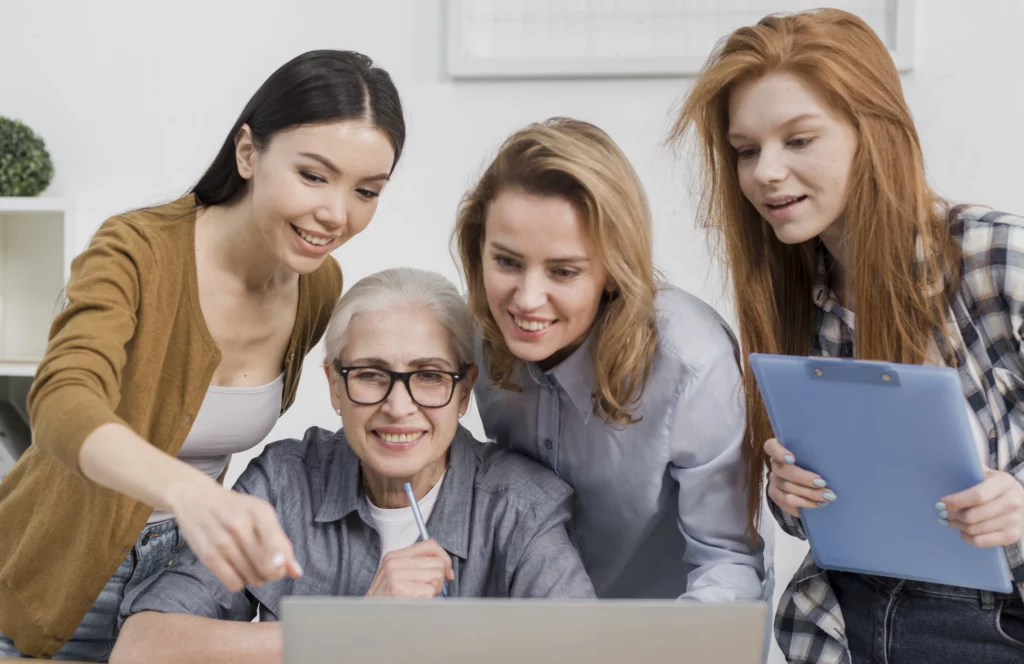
[455, 119, 764, 601]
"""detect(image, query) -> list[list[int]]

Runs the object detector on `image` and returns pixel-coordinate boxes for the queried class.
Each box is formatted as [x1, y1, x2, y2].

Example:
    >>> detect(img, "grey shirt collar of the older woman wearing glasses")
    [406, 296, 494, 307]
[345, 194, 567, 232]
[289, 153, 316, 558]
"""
[315, 425, 477, 559]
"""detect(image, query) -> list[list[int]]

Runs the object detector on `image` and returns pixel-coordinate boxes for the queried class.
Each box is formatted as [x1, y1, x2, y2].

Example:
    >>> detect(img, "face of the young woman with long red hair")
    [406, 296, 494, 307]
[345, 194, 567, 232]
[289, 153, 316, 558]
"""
[729, 73, 857, 244]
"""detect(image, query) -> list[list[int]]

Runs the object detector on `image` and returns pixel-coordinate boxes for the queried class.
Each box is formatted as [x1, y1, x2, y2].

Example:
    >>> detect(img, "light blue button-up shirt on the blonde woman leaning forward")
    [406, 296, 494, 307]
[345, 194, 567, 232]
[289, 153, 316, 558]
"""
[475, 287, 764, 601]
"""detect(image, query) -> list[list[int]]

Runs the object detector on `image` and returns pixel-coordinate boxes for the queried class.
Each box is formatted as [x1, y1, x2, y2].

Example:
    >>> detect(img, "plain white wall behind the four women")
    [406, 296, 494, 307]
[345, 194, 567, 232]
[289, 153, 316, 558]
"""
[0, 0, 1024, 659]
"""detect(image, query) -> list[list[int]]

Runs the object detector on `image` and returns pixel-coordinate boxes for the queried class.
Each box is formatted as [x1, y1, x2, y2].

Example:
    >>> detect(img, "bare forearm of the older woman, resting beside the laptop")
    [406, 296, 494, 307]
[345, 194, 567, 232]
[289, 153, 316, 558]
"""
[111, 611, 282, 664]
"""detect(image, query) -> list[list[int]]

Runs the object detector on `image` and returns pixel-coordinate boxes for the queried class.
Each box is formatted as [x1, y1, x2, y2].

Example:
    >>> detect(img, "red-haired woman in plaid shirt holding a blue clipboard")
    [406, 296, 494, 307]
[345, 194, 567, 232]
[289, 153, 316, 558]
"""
[675, 10, 1024, 664]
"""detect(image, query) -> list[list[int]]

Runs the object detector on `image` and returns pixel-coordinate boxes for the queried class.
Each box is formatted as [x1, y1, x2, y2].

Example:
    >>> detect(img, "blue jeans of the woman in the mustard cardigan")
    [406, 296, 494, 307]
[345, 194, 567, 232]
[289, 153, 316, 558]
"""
[0, 518, 184, 662]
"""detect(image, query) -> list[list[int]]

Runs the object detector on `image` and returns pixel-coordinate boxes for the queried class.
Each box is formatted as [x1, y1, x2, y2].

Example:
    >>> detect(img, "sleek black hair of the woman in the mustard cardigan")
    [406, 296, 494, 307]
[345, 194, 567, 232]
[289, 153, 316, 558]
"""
[191, 50, 406, 206]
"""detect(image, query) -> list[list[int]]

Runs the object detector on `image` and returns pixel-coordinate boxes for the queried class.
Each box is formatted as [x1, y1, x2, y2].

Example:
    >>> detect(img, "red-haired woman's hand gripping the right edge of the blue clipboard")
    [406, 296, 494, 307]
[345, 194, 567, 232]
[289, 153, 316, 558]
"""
[935, 468, 1024, 548]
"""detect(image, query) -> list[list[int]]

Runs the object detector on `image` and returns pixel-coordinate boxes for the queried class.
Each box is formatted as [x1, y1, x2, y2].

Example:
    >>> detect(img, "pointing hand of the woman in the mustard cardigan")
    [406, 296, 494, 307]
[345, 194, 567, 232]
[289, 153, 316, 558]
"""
[168, 481, 302, 592]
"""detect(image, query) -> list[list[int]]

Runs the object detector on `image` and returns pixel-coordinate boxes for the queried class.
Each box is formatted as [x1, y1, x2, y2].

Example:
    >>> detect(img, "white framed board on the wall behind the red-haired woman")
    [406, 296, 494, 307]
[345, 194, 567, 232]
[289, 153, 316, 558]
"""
[445, 0, 915, 79]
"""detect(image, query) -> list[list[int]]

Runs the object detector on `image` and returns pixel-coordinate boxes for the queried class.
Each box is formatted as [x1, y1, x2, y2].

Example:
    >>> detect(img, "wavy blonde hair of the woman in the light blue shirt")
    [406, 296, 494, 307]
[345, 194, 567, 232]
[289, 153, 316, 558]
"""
[454, 118, 658, 424]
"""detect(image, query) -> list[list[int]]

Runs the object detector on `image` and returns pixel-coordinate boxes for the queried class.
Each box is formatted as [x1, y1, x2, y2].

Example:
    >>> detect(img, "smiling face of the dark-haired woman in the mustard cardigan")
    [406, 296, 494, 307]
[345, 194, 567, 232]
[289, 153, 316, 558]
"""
[236, 120, 394, 274]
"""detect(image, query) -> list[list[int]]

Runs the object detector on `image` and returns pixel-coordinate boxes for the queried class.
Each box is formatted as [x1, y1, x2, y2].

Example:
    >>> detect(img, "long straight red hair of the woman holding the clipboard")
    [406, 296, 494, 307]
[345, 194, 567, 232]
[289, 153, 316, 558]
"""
[671, 9, 959, 531]
